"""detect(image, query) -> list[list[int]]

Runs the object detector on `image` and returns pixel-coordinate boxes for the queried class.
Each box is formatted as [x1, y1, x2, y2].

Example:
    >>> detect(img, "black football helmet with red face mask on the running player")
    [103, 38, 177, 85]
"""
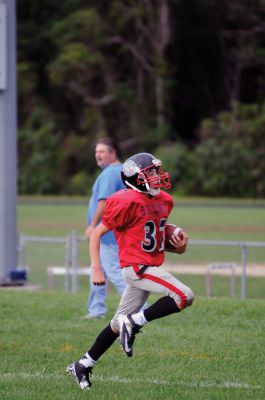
[121, 153, 171, 196]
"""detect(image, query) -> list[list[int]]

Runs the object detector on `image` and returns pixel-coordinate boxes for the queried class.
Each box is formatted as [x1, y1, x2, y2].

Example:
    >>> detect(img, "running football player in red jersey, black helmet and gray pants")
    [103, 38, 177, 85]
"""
[67, 153, 194, 389]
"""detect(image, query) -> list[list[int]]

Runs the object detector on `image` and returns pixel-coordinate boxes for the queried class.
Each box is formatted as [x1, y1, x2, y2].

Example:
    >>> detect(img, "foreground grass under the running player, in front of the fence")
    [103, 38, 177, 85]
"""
[0, 290, 265, 400]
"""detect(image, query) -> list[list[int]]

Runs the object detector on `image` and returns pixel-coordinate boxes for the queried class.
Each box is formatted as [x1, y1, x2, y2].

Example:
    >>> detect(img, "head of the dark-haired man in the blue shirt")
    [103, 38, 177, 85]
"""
[95, 138, 118, 169]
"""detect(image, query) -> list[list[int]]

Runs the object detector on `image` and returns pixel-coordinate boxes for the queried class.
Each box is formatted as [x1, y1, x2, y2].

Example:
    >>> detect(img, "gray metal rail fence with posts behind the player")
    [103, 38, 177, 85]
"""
[18, 231, 265, 300]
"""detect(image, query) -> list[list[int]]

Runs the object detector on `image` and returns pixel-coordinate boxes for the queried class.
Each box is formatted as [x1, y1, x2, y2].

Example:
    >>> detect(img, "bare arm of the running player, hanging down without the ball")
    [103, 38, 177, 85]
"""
[89, 223, 110, 286]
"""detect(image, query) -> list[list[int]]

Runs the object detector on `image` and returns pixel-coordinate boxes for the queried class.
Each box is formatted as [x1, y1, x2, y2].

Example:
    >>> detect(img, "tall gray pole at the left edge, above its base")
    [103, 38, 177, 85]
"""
[0, 0, 17, 281]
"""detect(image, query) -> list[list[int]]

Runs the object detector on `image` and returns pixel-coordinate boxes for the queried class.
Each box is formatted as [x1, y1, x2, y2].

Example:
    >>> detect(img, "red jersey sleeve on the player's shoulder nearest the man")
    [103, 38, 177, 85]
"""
[102, 197, 133, 229]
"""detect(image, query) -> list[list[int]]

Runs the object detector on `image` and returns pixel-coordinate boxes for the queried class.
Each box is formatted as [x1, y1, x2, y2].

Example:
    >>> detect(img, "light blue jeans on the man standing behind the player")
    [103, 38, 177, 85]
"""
[87, 243, 126, 317]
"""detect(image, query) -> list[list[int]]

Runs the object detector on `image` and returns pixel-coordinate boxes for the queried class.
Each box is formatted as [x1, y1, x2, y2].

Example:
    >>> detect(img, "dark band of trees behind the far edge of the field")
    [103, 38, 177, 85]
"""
[17, 0, 265, 197]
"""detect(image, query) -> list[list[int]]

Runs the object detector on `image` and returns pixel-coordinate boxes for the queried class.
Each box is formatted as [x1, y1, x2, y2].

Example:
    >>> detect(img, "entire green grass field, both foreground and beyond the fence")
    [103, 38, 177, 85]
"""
[0, 198, 265, 400]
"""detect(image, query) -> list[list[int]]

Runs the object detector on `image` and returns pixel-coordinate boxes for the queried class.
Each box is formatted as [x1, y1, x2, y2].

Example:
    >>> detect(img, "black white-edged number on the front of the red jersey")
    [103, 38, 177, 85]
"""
[142, 218, 167, 252]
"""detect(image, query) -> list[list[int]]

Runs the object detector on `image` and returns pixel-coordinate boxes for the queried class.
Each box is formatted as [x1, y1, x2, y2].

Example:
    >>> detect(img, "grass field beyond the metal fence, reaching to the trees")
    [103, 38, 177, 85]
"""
[18, 199, 265, 298]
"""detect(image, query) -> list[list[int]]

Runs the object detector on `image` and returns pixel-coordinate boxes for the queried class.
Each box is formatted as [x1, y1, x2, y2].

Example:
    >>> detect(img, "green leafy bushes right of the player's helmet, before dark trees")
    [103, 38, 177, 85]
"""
[156, 103, 265, 197]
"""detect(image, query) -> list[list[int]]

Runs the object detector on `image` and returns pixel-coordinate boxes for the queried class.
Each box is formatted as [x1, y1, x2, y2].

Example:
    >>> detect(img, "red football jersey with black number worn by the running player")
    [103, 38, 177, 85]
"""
[102, 189, 173, 267]
